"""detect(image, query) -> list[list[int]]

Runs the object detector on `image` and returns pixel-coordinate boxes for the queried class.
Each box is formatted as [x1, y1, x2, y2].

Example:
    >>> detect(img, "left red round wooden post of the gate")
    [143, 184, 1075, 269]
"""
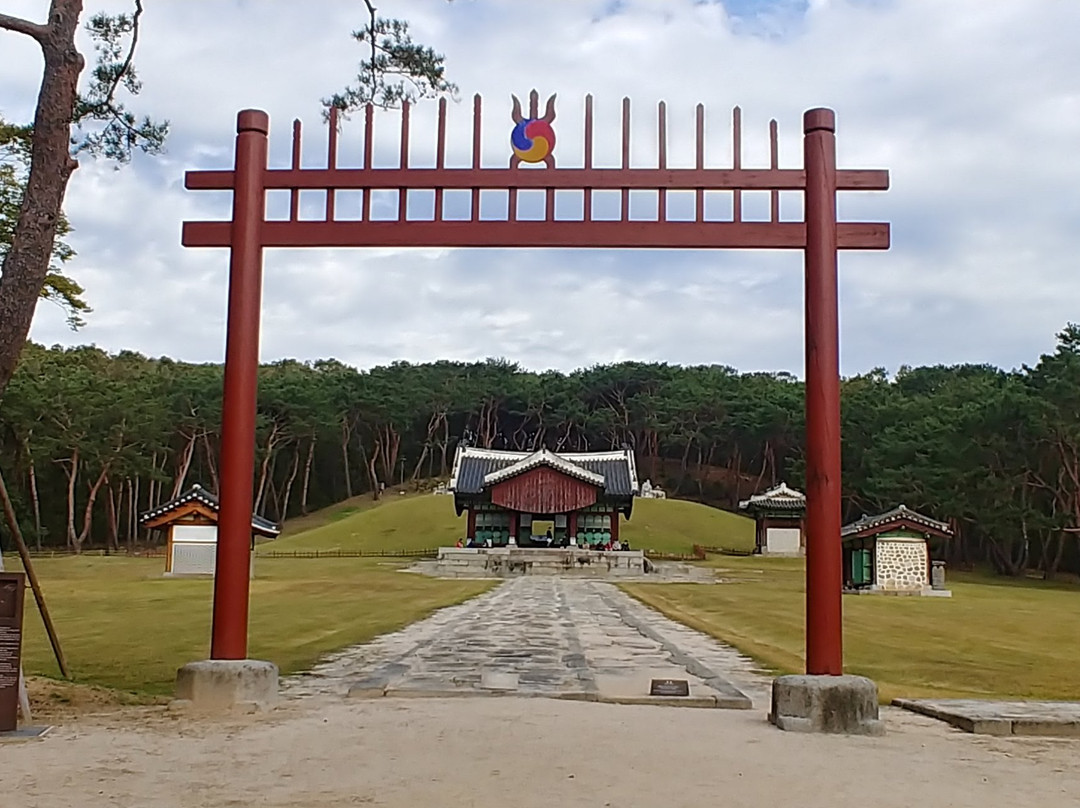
[211, 109, 270, 659]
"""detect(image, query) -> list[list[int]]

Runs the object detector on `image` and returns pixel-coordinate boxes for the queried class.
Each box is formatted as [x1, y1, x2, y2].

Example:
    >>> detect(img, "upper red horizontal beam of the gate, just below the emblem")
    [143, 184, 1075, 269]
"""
[184, 169, 889, 191]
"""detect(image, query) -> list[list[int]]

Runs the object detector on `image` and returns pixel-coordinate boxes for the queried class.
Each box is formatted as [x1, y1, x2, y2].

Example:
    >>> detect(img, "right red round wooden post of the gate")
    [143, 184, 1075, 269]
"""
[802, 109, 843, 676]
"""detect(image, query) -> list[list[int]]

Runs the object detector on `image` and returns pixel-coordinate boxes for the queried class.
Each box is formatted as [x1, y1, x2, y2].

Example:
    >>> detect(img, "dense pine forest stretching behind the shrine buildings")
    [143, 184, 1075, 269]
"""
[0, 325, 1080, 578]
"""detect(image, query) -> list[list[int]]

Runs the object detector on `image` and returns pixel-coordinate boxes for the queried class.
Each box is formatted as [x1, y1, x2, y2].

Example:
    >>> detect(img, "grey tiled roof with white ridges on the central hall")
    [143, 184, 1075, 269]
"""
[449, 446, 638, 497]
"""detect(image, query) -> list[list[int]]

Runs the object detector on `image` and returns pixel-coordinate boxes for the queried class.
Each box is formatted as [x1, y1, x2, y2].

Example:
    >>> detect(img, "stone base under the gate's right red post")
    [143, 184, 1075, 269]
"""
[769, 676, 885, 736]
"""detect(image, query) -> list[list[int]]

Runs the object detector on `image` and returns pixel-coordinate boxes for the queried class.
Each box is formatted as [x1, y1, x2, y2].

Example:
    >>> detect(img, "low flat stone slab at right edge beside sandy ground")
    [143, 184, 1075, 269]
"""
[892, 699, 1080, 738]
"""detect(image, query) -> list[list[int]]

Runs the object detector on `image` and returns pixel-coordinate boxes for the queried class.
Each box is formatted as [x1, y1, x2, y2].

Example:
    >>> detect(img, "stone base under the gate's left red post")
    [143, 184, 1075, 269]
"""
[174, 659, 278, 713]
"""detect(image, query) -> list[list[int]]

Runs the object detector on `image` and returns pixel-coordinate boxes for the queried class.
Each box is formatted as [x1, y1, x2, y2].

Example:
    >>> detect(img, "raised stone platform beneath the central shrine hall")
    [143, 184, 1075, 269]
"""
[423, 547, 651, 578]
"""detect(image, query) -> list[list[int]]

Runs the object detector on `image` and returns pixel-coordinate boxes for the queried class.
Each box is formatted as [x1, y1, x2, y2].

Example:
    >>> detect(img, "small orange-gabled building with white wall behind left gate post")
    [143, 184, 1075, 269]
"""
[139, 485, 281, 576]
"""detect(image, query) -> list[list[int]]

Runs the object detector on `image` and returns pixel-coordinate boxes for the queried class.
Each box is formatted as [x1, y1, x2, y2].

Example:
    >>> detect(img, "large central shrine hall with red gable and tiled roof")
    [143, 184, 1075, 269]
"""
[448, 446, 638, 547]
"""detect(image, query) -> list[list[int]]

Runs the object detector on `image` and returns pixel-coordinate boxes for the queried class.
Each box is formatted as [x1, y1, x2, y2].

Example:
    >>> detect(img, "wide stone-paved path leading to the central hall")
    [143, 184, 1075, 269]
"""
[283, 576, 769, 709]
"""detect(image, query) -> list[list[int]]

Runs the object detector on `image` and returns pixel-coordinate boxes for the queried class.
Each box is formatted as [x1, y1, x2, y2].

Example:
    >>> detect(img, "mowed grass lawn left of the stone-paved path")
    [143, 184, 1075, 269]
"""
[11, 556, 490, 695]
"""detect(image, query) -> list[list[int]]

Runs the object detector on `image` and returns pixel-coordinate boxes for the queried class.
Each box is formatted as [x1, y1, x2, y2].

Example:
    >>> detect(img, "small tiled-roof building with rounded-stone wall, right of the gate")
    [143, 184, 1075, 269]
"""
[840, 506, 953, 594]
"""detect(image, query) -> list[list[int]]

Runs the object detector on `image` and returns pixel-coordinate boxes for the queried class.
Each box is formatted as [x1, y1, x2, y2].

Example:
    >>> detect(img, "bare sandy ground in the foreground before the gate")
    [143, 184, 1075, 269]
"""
[0, 697, 1080, 808]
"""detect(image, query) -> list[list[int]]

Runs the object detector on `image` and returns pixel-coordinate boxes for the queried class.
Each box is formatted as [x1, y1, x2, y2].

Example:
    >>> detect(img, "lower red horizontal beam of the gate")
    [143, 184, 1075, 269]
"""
[183, 220, 889, 250]
